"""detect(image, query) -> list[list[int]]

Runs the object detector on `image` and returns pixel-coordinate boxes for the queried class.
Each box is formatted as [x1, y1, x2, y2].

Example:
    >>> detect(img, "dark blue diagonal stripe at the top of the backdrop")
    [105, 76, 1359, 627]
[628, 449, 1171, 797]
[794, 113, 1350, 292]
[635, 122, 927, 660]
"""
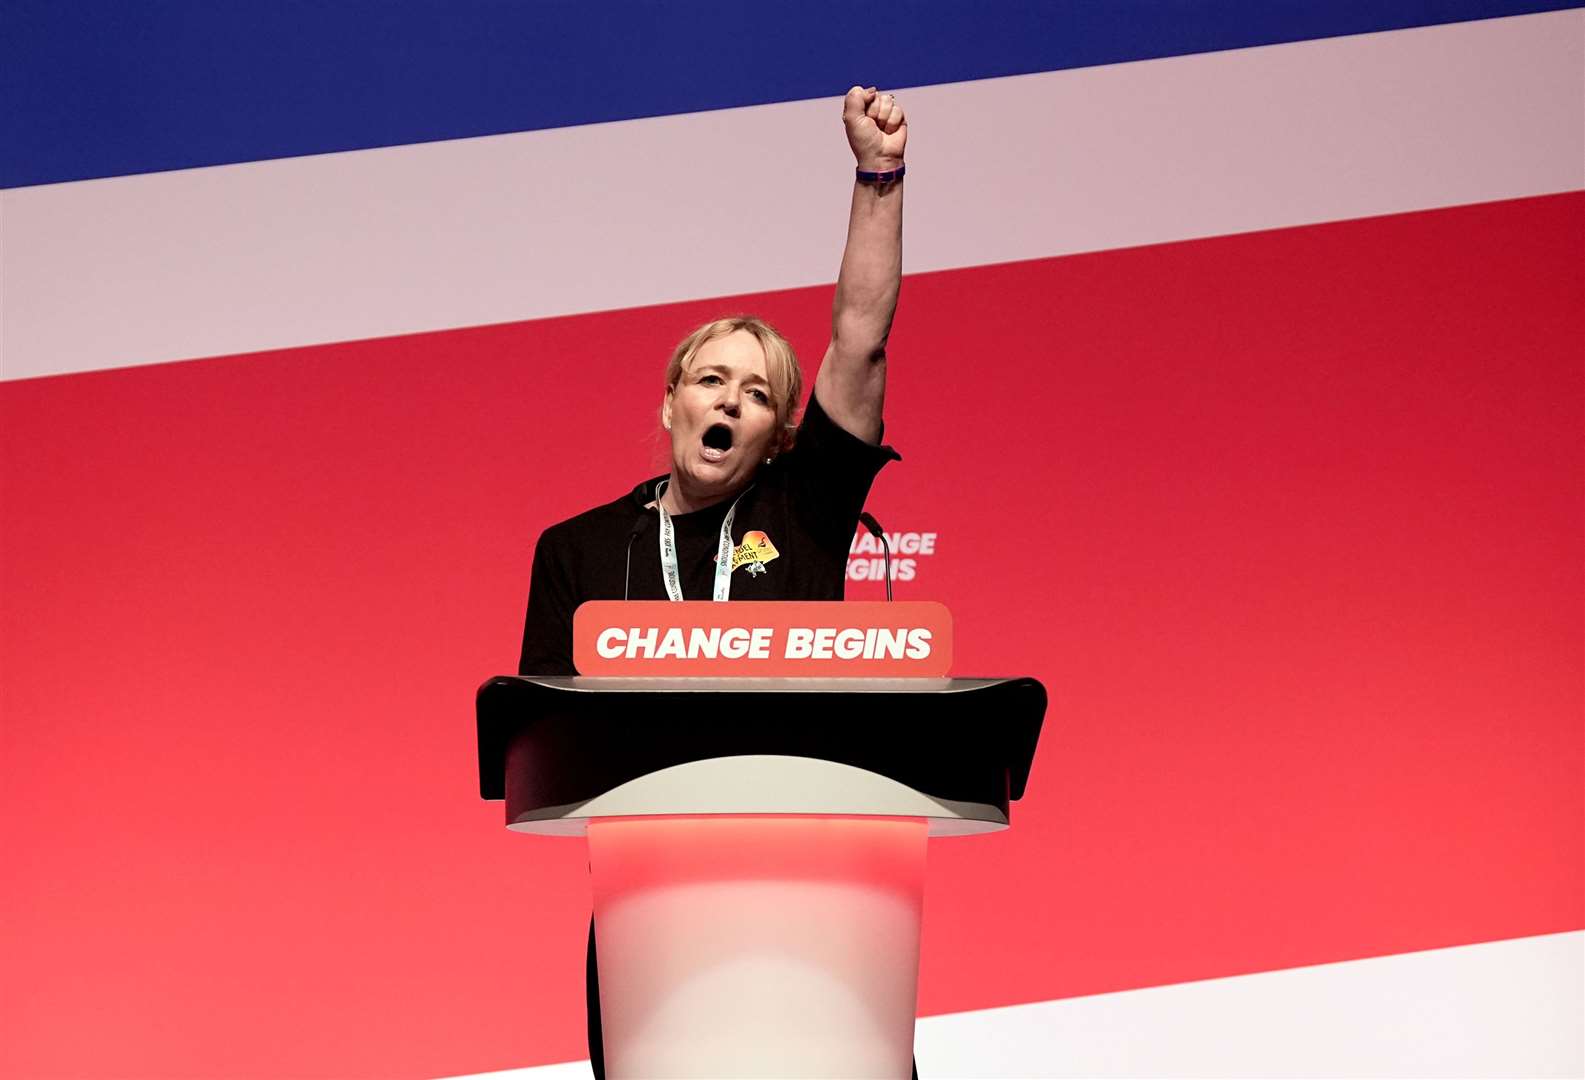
[0, 0, 1580, 187]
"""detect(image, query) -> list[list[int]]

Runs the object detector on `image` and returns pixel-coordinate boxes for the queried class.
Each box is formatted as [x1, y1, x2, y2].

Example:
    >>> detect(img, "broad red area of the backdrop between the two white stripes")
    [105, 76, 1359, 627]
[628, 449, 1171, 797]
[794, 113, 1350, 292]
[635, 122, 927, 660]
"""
[0, 193, 1585, 1077]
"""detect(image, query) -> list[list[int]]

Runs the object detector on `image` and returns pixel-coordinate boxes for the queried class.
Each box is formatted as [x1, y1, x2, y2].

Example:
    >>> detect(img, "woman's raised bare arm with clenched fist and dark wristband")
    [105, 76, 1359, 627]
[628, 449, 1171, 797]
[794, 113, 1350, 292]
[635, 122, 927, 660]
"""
[815, 86, 908, 442]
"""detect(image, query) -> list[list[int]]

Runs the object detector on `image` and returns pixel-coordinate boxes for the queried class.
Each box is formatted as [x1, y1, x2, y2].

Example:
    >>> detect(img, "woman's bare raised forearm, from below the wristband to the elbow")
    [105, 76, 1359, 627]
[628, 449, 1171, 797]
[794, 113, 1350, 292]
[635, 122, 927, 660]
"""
[831, 179, 907, 357]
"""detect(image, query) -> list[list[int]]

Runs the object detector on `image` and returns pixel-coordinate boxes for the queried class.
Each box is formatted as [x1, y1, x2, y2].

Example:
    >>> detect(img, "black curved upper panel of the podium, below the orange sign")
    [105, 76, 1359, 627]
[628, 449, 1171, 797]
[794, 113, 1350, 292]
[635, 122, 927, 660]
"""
[477, 676, 1046, 821]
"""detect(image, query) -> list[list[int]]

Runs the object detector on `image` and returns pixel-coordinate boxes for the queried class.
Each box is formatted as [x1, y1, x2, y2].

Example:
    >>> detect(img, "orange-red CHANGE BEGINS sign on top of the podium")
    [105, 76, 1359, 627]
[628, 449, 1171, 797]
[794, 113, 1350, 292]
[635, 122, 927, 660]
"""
[572, 599, 953, 679]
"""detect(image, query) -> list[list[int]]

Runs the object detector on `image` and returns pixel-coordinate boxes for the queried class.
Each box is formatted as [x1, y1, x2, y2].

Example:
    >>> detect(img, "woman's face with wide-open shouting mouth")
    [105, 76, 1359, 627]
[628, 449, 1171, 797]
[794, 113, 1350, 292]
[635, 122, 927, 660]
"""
[661, 330, 777, 509]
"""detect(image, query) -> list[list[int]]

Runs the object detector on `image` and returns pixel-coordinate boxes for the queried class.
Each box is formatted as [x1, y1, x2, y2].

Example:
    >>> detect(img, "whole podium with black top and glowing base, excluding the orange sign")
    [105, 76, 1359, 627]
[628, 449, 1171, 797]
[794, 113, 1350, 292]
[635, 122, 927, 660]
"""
[477, 676, 1046, 1080]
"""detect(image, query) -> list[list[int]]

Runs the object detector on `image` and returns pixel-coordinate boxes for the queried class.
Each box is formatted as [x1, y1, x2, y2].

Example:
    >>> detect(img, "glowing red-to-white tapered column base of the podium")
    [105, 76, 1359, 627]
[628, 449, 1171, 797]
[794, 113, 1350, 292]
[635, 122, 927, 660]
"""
[588, 817, 926, 1077]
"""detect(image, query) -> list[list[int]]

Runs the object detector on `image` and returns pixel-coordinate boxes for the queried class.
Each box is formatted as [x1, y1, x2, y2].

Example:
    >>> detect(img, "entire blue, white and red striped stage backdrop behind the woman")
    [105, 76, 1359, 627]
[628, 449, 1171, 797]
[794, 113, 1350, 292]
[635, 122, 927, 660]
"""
[0, 0, 1585, 1078]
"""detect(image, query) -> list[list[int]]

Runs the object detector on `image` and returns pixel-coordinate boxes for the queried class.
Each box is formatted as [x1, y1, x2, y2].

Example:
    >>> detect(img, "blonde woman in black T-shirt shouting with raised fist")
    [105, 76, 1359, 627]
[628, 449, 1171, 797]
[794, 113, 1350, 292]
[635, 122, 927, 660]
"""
[518, 86, 908, 1077]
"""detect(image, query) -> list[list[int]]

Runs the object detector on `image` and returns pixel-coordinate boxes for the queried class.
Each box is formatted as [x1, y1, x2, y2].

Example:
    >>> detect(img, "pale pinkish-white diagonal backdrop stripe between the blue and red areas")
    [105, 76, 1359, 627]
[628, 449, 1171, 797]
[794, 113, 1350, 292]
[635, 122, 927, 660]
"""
[0, 11, 1585, 379]
